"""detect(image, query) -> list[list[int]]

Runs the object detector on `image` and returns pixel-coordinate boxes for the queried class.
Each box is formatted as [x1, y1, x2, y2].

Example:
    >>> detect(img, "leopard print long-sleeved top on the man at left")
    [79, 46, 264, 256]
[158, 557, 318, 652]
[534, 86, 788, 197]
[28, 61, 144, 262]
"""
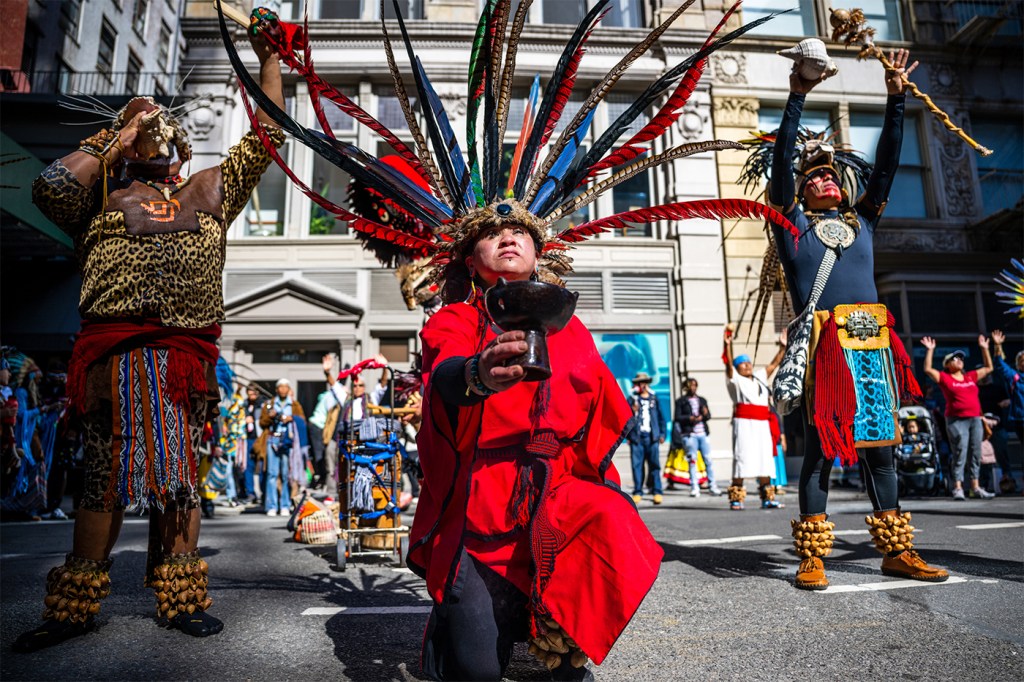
[33, 130, 285, 329]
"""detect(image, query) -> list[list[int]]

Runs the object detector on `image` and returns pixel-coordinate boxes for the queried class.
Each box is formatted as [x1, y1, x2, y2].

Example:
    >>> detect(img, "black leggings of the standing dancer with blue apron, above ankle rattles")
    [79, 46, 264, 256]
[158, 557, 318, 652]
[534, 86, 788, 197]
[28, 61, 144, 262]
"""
[800, 411, 899, 515]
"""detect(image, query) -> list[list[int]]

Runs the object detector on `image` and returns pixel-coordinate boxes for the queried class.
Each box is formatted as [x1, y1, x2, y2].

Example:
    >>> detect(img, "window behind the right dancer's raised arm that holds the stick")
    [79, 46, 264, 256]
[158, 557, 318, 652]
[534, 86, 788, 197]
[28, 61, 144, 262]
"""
[850, 112, 928, 218]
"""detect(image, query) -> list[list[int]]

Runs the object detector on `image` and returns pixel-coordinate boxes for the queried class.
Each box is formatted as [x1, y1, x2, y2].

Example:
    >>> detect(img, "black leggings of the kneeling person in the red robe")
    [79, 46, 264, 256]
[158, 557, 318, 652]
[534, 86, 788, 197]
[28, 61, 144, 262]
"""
[421, 551, 529, 680]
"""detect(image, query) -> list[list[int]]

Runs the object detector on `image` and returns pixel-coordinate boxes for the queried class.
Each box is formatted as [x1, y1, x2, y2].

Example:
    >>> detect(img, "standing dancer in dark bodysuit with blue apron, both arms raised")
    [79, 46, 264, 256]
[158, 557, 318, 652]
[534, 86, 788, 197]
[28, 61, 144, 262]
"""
[768, 49, 948, 590]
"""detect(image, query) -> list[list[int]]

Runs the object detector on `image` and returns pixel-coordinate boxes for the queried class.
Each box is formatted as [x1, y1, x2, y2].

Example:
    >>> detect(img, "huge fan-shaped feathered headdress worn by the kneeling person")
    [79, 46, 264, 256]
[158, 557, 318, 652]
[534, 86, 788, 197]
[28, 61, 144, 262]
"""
[220, 0, 796, 301]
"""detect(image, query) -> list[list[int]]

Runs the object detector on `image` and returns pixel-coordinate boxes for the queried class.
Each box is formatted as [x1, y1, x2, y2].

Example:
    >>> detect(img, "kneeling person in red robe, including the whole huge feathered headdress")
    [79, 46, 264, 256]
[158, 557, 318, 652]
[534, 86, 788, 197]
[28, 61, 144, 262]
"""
[220, 0, 796, 680]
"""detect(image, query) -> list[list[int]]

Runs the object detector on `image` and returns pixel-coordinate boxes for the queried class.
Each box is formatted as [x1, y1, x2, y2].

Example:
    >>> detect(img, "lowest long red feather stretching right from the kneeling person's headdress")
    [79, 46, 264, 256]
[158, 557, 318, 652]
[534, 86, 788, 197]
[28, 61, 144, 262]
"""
[556, 199, 800, 244]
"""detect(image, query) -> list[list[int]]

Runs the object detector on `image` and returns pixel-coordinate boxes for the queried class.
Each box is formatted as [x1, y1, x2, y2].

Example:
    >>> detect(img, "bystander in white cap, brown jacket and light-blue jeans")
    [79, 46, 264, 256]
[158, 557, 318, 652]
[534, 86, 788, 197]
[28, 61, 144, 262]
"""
[260, 378, 305, 516]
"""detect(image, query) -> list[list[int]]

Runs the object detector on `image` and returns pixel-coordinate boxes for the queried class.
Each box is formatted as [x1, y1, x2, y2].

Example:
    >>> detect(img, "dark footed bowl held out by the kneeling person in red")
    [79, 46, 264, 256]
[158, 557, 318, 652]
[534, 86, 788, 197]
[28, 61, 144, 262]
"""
[483, 279, 580, 381]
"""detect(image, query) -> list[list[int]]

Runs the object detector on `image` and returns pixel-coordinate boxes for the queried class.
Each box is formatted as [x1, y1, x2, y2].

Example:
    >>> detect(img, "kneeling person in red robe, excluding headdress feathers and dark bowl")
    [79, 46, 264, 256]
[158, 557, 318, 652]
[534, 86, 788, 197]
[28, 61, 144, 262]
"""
[409, 200, 663, 680]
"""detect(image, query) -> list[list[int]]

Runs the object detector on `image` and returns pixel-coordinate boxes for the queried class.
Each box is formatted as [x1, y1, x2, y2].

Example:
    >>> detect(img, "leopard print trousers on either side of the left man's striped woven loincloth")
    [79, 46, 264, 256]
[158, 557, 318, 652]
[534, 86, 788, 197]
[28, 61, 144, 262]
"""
[80, 387, 207, 512]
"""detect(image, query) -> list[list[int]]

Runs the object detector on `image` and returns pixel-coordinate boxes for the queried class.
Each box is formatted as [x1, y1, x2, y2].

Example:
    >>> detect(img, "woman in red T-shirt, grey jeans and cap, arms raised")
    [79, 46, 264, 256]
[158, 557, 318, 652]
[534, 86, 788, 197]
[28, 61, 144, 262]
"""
[921, 335, 995, 500]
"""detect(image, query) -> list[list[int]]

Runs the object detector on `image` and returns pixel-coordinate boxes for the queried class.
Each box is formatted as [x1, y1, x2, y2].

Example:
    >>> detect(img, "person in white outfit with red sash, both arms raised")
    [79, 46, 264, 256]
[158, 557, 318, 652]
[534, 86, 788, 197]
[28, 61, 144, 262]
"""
[722, 328, 785, 511]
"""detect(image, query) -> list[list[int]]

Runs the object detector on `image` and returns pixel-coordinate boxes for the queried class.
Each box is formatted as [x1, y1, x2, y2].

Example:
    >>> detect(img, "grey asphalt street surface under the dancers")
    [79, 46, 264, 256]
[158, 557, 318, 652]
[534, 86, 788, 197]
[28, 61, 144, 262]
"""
[0, 475, 1024, 681]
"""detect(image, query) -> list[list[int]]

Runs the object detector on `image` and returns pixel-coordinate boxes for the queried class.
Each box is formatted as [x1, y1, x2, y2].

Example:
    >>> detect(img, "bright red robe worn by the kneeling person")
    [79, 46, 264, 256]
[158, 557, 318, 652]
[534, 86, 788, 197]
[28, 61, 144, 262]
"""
[409, 303, 664, 664]
